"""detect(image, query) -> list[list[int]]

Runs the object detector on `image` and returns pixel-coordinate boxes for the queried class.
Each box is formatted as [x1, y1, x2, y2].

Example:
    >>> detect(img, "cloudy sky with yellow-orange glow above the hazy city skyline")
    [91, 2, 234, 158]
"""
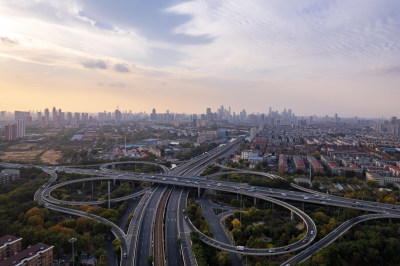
[0, 0, 400, 117]
